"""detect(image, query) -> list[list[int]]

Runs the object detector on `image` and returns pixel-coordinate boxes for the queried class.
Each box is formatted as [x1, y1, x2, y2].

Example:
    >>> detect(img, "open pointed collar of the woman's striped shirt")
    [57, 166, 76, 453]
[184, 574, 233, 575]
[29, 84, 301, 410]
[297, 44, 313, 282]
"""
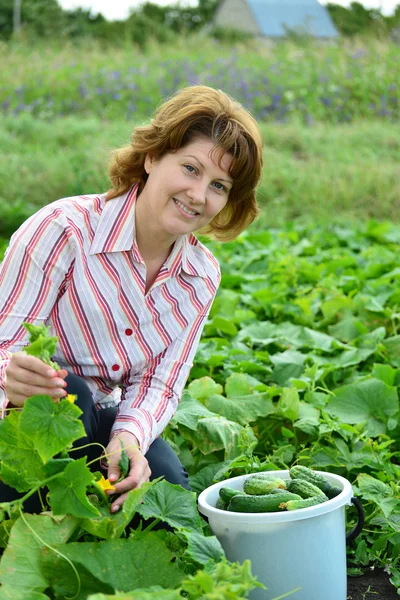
[89, 184, 207, 277]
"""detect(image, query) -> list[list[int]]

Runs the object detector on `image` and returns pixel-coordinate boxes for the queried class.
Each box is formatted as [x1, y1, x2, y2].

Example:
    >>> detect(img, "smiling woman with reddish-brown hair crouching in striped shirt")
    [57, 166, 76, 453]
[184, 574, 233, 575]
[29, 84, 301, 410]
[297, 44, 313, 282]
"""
[0, 86, 262, 512]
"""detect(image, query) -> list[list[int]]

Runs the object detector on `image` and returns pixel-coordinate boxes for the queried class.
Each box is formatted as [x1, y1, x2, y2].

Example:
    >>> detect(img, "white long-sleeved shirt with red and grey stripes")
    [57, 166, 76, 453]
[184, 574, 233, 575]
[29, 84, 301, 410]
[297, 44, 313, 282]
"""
[0, 186, 220, 452]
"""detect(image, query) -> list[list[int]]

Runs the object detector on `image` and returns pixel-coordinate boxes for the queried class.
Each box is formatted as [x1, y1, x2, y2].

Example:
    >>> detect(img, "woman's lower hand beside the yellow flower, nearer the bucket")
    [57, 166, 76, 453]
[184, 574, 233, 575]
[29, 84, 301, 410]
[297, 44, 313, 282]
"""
[106, 431, 151, 512]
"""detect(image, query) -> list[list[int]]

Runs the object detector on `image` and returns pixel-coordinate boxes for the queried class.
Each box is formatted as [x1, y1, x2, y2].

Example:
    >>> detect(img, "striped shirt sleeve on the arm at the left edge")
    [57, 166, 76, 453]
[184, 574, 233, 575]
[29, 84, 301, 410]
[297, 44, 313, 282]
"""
[0, 207, 73, 413]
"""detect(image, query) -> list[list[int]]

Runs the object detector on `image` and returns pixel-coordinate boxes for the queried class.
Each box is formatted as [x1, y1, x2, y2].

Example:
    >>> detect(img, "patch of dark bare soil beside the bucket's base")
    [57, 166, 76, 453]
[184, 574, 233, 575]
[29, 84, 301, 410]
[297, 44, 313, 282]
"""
[347, 569, 400, 600]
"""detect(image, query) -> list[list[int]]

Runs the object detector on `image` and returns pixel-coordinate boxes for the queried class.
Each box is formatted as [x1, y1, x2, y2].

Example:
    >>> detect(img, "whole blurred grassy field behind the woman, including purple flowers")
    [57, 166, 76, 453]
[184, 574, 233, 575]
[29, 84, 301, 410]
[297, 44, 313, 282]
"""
[0, 37, 400, 237]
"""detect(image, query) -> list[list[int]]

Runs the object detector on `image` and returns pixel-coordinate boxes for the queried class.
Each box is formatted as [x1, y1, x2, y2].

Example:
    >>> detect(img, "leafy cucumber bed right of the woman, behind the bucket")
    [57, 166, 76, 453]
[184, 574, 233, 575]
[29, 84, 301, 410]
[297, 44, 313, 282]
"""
[167, 222, 400, 588]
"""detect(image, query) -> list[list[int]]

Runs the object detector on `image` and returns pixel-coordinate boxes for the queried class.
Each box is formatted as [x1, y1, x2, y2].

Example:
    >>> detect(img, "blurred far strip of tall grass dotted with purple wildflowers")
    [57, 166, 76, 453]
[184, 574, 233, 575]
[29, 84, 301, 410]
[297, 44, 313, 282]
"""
[0, 36, 400, 123]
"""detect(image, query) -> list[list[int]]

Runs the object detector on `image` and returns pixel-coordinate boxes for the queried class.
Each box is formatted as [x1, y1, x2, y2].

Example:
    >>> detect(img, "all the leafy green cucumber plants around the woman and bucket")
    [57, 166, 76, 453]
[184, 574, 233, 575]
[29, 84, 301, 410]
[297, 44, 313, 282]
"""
[0, 222, 400, 600]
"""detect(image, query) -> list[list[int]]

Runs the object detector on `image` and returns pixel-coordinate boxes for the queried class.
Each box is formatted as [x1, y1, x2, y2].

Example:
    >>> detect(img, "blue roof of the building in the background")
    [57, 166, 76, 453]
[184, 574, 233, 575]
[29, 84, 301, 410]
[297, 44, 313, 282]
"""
[247, 0, 338, 37]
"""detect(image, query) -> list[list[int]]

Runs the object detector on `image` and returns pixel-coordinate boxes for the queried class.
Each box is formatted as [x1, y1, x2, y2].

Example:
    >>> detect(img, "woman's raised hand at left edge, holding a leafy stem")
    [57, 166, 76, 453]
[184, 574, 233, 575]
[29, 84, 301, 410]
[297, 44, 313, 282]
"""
[4, 351, 68, 407]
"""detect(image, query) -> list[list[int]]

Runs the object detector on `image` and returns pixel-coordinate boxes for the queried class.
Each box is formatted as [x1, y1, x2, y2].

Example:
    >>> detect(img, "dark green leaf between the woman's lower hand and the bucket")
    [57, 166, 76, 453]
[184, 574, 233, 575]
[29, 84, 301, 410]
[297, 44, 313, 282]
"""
[137, 481, 203, 531]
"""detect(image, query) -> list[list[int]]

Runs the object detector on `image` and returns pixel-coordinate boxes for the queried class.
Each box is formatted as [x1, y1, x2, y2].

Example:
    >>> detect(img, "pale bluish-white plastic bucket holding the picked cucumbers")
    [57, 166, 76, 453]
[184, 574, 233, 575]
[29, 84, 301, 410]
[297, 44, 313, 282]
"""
[198, 471, 363, 600]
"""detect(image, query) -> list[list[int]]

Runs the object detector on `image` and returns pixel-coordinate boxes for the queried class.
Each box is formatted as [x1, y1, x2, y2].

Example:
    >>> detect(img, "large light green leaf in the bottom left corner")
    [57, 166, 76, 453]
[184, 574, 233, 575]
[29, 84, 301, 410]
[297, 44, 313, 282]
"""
[0, 514, 77, 598]
